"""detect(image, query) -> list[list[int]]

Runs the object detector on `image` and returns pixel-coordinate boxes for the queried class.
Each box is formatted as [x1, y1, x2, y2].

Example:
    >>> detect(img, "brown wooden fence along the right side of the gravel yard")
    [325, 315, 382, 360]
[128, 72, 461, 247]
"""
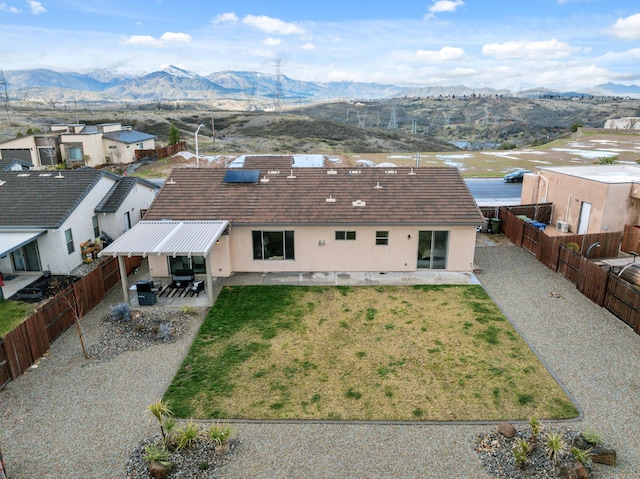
[497, 207, 640, 334]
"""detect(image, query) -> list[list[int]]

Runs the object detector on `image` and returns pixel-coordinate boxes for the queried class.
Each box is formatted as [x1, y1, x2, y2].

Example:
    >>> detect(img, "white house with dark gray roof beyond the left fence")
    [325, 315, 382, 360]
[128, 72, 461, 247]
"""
[0, 168, 157, 274]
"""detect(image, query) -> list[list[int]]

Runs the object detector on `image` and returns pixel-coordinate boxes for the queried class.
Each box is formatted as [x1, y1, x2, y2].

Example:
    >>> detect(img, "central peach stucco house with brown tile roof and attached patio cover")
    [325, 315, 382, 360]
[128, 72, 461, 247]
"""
[104, 161, 484, 300]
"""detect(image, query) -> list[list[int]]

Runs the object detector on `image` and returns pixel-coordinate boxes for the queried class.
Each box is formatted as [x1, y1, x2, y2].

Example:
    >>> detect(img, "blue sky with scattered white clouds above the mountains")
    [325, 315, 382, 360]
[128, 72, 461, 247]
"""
[0, 0, 640, 91]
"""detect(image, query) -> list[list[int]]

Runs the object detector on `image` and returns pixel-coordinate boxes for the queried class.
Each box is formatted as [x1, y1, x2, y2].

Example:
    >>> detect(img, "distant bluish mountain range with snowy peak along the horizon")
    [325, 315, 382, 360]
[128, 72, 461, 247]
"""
[0, 66, 640, 102]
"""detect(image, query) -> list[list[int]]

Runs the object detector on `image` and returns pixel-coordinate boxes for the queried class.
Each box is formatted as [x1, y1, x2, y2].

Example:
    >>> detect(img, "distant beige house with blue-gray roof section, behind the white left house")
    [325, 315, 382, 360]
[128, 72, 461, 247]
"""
[0, 123, 157, 167]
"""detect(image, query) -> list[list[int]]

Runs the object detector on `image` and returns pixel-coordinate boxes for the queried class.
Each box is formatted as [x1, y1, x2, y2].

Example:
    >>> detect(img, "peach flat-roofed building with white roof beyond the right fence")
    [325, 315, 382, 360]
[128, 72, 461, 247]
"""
[520, 164, 640, 234]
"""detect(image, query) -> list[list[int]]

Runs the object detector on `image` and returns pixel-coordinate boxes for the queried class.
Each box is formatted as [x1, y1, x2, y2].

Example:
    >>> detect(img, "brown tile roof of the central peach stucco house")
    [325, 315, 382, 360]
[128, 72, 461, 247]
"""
[145, 167, 484, 226]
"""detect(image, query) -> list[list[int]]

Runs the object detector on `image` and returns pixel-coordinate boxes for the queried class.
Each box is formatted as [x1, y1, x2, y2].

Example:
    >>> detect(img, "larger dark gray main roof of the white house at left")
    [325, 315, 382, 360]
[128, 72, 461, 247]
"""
[0, 168, 122, 230]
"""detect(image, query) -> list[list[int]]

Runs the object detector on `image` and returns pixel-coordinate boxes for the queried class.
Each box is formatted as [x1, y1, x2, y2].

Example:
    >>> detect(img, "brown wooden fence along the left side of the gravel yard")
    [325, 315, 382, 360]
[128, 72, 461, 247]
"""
[0, 257, 142, 389]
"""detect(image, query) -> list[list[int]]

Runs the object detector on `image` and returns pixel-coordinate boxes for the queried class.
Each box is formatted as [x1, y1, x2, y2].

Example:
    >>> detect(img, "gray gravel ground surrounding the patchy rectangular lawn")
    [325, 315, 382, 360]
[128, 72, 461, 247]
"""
[0, 246, 640, 479]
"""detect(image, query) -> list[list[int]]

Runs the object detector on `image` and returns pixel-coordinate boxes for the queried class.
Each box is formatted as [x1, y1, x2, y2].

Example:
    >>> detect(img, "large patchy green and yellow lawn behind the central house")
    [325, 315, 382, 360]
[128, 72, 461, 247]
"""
[164, 285, 577, 421]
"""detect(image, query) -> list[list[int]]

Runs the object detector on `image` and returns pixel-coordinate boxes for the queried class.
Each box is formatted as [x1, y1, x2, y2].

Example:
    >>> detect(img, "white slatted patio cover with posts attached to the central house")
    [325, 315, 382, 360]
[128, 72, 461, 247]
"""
[99, 220, 229, 306]
